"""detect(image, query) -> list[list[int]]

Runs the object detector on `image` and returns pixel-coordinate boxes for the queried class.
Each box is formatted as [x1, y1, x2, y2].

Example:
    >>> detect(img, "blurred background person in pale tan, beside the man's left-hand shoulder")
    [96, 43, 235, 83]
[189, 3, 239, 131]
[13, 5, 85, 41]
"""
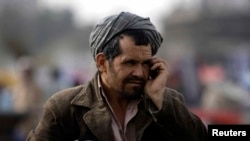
[13, 56, 42, 113]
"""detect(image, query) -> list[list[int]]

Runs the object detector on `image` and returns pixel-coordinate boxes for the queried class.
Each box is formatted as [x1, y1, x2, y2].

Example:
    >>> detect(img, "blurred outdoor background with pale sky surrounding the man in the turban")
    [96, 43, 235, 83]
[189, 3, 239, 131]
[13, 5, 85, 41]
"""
[0, 0, 250, 141]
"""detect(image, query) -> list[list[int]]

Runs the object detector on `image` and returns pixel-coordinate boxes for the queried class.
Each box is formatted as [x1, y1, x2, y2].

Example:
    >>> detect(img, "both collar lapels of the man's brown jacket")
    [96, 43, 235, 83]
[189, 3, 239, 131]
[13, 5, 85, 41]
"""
[71, 73, 153, 141]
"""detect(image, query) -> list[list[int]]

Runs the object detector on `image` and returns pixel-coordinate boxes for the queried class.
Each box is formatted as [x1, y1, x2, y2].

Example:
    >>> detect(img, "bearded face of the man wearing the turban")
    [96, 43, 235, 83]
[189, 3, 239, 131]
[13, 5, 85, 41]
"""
[106, 36, 152, 99]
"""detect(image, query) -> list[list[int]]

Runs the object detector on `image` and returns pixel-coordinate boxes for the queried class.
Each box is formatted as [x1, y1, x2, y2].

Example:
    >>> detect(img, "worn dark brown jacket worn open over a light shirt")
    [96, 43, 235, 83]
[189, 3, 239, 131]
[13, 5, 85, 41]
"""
[27, 73, 207, 141]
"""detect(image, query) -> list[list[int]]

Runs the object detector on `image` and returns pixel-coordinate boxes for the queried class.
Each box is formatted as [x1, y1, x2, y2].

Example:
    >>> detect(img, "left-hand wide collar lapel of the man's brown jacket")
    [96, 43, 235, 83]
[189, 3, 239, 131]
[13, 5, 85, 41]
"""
[71, 73, 114, 141]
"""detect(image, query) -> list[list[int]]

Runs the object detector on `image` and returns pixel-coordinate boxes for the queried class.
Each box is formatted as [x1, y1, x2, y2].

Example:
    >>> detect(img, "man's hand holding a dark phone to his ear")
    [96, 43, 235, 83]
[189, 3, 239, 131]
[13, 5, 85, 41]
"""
[144, 58, 168, 110]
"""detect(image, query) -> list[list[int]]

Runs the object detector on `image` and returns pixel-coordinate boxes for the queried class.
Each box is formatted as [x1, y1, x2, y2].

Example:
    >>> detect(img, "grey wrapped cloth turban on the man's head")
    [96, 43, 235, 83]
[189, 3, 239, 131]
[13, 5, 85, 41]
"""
[89, 12, 163, 59]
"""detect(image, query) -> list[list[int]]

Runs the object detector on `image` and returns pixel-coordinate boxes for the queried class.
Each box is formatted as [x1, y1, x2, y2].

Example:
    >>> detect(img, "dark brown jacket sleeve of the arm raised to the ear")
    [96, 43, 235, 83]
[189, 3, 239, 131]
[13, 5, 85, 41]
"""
[151, 88, 208, 141]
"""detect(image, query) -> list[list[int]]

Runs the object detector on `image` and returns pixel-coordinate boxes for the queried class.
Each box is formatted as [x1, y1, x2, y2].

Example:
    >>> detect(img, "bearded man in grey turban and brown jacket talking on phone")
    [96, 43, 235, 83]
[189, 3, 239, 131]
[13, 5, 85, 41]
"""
[27, 12, 207, 141]
